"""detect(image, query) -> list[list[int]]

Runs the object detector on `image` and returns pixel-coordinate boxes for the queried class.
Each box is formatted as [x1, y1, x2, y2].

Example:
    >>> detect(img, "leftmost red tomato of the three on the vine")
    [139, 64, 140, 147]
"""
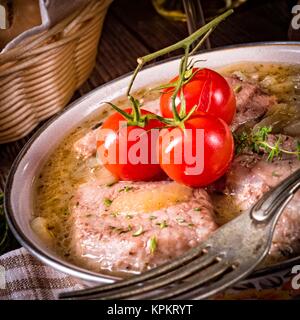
[97, 109, 163, 181]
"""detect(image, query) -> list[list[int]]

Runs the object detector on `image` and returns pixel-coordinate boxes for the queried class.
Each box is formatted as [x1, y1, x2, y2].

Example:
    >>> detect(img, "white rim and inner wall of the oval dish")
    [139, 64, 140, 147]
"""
[5, 42, 300, 283]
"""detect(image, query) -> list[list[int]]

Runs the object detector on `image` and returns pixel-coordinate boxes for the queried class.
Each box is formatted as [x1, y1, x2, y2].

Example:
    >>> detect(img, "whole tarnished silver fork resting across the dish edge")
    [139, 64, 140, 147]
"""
[60, 169, 300, 300]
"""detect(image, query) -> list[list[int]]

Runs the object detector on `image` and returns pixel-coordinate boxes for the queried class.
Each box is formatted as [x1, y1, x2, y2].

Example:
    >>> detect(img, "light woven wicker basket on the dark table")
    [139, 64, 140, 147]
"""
[0, 0, 112, 144]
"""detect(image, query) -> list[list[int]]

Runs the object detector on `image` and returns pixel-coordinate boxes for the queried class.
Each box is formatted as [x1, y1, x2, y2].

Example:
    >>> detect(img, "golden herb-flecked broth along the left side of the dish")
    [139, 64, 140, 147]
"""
[32, 90, 159, 263]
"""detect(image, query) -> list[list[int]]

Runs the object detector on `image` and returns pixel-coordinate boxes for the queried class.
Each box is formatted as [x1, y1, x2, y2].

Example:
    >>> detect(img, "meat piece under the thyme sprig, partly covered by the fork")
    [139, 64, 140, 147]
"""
[213, 137, 300, 259]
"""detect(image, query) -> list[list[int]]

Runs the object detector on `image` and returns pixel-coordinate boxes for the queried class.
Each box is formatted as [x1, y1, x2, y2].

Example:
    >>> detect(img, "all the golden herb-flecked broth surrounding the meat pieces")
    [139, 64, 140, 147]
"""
[33, 63, 300, 268]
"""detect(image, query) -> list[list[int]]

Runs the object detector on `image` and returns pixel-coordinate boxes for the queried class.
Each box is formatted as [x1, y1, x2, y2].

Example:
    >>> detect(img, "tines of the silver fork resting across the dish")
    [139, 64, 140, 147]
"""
[60, 245, 239, 300]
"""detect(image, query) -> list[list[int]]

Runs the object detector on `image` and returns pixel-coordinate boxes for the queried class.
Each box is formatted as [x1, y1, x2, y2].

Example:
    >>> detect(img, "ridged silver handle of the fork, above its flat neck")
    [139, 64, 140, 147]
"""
[251, 169, 300, 222]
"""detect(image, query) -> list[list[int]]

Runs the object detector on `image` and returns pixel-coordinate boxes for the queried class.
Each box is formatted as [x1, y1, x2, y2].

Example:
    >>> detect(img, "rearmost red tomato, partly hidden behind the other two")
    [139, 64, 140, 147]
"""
[160, 68, 236, 124]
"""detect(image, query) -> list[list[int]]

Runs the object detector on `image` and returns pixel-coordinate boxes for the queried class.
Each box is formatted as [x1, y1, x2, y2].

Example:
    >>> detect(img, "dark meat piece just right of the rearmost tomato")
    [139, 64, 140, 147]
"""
[226, 76, 276, 131]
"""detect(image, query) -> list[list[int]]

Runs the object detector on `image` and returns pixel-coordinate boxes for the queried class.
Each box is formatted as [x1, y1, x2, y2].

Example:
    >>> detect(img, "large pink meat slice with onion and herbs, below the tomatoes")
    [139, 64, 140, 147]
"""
[70, 181, 217, 272]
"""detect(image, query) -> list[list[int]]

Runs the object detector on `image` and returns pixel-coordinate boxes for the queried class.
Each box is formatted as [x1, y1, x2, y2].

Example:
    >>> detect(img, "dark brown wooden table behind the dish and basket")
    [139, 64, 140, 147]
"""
[0, 0, 297, 249]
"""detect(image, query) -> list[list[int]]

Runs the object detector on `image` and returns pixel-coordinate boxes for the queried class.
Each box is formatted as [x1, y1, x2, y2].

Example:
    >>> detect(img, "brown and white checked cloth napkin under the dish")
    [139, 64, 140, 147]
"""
[0, 248, 84, 300]
